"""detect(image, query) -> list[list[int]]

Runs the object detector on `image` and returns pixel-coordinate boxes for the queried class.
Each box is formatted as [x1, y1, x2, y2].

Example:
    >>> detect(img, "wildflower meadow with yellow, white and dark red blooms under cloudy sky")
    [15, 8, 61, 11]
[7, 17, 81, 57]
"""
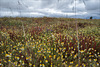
[0, 17, 100, 67]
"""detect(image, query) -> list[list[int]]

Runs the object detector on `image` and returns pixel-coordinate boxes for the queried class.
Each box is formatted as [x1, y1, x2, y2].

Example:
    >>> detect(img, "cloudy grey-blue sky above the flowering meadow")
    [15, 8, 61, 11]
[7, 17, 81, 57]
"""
[0, 0, 100, 19]
